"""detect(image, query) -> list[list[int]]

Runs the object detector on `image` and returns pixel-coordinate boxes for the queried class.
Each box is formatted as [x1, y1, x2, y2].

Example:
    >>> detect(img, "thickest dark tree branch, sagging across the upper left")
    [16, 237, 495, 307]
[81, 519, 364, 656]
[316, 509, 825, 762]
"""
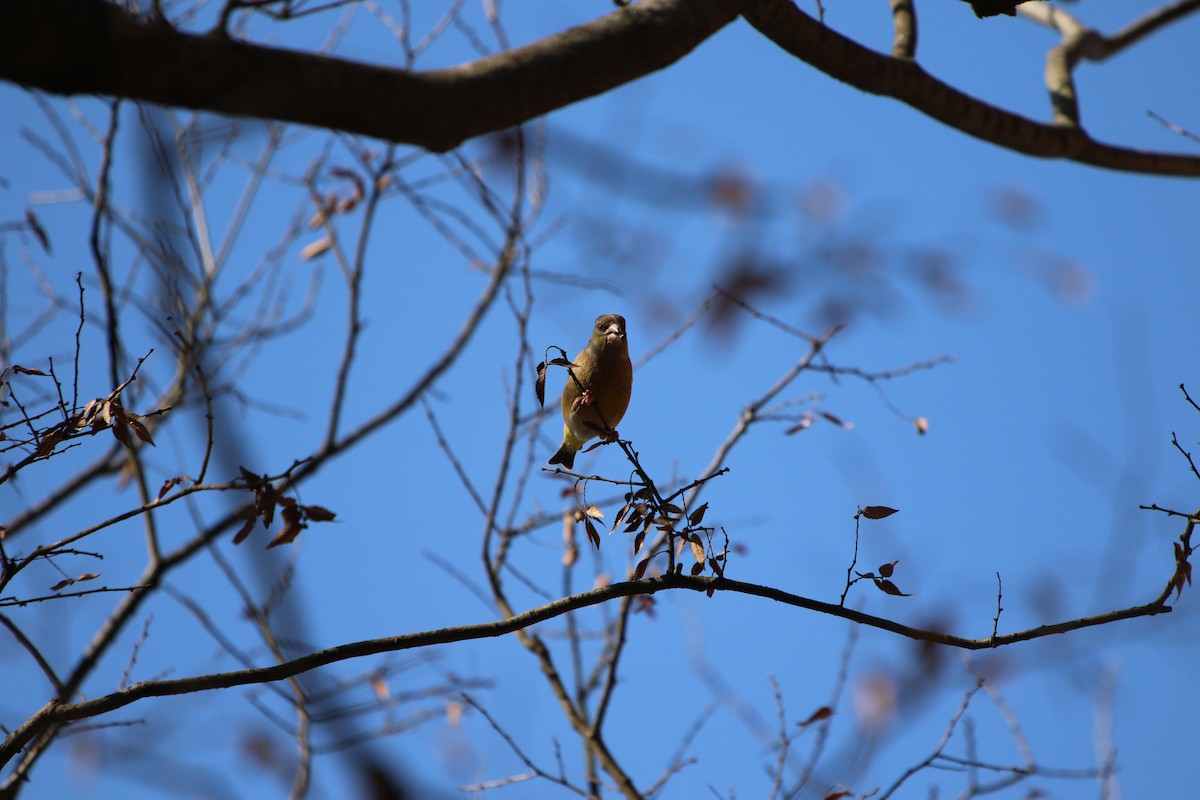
[0, 0, 743, 151]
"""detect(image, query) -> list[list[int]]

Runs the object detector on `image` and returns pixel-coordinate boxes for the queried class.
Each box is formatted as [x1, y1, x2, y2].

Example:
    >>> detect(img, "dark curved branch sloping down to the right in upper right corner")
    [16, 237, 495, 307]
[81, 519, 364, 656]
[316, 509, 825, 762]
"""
[743, 0, 1200, 176]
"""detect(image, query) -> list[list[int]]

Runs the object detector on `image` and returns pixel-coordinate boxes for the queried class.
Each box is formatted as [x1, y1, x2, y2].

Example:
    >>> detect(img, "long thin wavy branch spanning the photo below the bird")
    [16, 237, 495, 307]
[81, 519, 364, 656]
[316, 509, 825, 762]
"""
[0, 575, 1171, 765]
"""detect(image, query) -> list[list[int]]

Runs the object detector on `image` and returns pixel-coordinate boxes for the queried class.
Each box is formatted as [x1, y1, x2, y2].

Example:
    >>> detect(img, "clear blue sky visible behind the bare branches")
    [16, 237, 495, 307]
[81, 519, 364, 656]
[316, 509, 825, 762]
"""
[0, 4, 1200, 798]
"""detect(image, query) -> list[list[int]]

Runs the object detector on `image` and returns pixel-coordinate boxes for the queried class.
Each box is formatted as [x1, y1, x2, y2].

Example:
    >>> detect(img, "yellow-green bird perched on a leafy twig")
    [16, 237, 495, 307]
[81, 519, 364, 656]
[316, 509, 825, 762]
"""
[550, 314, 634, 469]
